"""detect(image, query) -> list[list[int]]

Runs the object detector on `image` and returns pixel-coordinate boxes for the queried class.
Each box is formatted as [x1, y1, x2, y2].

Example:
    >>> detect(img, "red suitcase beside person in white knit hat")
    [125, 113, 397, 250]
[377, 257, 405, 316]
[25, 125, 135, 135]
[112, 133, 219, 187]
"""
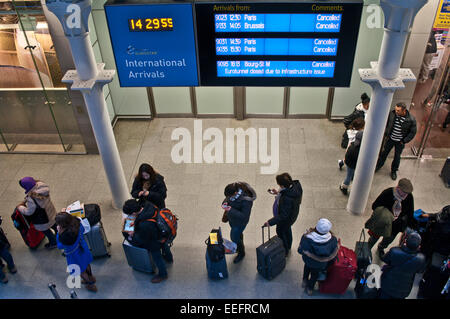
[319, 241, 358, 295]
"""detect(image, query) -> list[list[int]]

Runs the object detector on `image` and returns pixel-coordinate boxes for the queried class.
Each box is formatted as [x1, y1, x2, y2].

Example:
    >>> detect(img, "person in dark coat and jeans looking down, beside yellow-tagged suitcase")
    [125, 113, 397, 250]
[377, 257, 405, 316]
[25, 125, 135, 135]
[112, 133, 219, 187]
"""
[222, 182, 256, 264]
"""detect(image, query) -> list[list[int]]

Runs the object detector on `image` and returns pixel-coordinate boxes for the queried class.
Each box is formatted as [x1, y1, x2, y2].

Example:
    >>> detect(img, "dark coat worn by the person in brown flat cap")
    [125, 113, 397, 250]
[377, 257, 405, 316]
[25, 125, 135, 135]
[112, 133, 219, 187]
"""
[372, 187, 417, 233]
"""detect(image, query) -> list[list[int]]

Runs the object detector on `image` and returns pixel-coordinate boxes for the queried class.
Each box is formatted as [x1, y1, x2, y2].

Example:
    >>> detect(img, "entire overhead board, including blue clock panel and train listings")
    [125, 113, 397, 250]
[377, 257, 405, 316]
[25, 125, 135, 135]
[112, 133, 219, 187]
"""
[105, 0, 363, 87]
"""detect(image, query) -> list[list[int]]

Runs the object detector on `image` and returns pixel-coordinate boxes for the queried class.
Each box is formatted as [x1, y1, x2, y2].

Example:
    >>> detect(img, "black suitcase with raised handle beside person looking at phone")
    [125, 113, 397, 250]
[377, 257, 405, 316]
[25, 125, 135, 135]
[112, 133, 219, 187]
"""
[256, 226, 286, 280]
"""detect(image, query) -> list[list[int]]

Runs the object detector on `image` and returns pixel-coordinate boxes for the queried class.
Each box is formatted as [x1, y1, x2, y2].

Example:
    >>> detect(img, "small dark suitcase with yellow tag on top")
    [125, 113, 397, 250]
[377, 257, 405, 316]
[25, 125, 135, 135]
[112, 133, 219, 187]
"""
[205, 227, 228, 280]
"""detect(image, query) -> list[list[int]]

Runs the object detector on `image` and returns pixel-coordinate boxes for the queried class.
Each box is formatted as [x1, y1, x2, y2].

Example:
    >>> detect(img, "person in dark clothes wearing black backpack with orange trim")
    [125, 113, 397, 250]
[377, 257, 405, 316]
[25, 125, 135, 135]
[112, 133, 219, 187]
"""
[122, 199, 173, 284]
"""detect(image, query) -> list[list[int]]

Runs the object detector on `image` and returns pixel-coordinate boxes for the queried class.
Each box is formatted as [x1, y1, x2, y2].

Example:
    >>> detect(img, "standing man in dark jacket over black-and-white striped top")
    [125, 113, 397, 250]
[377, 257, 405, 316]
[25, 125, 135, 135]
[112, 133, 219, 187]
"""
[375, 103, 417, 181]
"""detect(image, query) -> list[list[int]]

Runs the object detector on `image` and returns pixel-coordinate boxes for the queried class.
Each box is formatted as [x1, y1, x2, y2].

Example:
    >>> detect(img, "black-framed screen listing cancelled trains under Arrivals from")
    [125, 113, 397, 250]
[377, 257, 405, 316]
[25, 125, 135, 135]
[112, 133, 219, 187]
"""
[195, 0, 363, 87]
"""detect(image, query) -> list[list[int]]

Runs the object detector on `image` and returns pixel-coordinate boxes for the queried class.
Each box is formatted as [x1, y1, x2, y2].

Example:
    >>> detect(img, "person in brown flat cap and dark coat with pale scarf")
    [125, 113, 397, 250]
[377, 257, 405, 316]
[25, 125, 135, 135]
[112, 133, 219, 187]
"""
[372, 178, 417, 257]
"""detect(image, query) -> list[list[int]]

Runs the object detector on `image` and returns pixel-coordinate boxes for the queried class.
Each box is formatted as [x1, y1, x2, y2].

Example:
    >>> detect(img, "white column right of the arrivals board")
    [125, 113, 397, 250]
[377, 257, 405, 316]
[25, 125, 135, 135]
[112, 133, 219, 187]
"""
[347, 0, 427, 215]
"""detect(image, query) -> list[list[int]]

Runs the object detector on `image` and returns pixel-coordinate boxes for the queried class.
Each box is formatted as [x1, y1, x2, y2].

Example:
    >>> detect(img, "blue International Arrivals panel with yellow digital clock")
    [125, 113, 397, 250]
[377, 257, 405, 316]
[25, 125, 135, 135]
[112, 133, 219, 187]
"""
[105, 1, 198, 87]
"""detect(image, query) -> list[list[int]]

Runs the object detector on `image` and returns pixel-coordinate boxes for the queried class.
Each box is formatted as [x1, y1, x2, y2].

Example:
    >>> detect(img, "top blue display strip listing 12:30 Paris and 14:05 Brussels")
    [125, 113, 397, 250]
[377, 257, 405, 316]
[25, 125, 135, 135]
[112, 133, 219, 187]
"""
[214, 13, 342, 32]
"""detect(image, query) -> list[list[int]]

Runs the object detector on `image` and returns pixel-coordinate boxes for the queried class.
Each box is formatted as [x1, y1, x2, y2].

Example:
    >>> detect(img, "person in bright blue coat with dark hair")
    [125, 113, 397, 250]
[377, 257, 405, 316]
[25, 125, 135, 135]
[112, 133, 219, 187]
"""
[56, 212, 97, 292]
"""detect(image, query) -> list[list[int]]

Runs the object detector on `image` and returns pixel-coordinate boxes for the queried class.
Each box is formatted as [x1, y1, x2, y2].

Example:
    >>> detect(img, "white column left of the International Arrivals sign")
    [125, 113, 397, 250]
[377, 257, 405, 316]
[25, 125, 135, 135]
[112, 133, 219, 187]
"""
[46, 0, 131, 209]
